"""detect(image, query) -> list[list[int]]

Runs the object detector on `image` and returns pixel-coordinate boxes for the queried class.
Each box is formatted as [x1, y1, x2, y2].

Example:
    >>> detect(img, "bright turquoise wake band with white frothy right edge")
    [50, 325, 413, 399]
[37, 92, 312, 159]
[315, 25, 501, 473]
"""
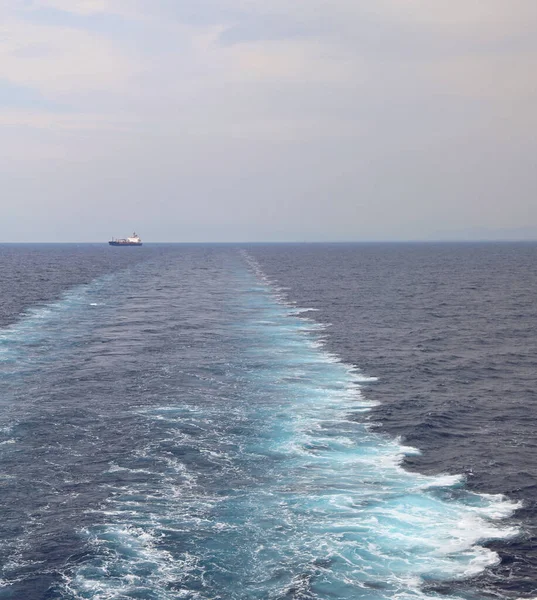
[234, 252, 520, 598]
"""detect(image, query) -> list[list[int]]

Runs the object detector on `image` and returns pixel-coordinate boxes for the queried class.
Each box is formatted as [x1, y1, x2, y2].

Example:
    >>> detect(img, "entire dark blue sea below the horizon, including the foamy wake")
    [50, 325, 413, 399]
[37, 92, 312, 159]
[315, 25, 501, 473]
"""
[0, 243, 537, 600]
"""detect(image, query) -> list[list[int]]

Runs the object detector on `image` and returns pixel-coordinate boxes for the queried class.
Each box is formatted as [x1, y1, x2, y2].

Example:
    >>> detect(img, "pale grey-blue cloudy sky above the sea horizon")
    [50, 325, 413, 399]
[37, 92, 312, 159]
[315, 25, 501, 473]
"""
[0, 0, 537, 242]
